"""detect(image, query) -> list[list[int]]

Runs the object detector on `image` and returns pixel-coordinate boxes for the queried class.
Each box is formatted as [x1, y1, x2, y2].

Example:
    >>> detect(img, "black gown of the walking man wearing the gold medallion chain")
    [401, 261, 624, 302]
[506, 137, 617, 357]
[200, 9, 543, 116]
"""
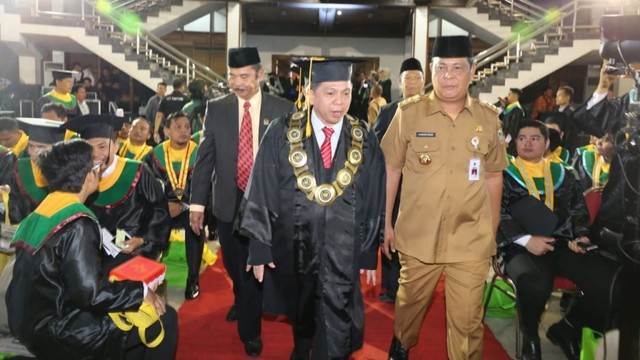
[240, 112, 386, 358]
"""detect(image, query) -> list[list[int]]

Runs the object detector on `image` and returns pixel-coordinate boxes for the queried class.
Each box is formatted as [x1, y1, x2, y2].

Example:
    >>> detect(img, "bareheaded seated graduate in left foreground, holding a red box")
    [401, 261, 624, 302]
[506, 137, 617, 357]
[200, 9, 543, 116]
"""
[3, 140, 178, 359]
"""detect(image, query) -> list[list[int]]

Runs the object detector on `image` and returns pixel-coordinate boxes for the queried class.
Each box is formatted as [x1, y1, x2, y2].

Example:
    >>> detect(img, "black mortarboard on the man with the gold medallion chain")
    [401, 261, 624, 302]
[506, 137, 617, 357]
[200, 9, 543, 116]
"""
[295, 58, 361, 85]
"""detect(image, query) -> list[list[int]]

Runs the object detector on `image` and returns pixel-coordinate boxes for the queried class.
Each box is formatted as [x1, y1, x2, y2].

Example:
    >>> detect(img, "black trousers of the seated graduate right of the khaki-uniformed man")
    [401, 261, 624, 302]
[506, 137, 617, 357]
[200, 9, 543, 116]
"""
[505, 244, 619, 339]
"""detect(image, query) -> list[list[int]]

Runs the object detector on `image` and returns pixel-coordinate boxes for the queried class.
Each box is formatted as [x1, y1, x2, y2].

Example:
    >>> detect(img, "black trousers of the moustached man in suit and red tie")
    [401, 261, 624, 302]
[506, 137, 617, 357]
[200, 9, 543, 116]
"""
[218, 190, 262, 342]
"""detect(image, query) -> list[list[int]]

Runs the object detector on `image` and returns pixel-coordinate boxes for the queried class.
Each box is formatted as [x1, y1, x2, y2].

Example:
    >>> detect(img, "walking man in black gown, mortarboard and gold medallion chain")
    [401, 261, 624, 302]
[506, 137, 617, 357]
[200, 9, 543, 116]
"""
[240, 59, 385, 359]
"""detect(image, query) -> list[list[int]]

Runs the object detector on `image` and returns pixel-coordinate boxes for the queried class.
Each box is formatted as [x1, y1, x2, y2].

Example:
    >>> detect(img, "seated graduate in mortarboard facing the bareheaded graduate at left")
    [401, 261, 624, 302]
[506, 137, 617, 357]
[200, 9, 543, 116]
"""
[62, 115, 171, 269]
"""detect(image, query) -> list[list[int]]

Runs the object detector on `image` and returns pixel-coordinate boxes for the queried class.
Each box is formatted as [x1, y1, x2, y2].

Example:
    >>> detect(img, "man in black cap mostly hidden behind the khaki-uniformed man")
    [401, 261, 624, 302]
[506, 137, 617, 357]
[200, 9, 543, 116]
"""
[373, 58, 424, 303]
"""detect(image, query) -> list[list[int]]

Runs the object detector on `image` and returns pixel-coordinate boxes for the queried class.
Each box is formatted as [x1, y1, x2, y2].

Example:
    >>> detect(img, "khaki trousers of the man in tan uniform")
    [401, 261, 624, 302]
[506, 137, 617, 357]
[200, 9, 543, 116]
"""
[394, 253, 490, 360]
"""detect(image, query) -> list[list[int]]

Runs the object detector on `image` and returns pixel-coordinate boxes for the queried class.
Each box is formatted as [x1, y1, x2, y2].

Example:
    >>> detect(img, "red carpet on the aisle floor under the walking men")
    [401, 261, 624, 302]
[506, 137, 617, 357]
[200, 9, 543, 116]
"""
[177, 258, 510, 360]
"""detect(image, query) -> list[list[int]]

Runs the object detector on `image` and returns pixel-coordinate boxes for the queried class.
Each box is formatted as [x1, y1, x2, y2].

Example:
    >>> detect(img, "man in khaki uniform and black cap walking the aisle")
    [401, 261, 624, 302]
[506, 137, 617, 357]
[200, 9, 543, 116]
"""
[381, 36, 507, 360]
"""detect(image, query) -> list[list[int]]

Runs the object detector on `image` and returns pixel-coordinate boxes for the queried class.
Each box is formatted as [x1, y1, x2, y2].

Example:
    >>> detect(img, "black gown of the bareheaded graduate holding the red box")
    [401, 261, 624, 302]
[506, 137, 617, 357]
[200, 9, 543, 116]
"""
[6, 216, 144, 360]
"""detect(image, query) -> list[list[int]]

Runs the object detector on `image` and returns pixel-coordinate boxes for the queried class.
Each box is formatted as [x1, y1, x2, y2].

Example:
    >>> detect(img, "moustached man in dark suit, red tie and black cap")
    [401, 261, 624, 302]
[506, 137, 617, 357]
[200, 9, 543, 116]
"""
[190, 47, 294, 356]
